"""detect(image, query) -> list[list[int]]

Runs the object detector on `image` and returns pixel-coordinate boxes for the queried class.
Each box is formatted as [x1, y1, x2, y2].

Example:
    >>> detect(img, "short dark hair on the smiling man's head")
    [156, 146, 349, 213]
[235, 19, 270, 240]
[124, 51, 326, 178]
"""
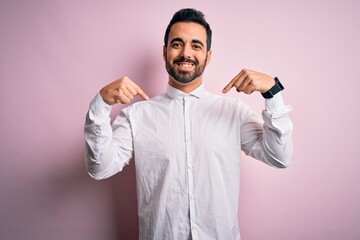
[164, 8, 212, 51]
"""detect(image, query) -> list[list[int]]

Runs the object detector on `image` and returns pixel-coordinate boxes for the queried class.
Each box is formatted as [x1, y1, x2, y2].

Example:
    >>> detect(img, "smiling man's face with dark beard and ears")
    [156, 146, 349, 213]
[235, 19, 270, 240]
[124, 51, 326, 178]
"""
[163, 22, 211, 84]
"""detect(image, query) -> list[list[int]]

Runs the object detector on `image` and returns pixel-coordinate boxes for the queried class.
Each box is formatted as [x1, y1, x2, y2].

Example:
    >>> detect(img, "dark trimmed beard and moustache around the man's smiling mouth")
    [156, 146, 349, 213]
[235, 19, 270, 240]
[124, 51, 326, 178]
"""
[166, 57, 207, 84]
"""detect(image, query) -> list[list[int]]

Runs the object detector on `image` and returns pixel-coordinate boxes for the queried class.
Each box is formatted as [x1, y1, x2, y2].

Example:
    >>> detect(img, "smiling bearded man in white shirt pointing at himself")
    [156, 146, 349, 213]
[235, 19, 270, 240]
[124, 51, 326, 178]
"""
[85, 9, 292, 240]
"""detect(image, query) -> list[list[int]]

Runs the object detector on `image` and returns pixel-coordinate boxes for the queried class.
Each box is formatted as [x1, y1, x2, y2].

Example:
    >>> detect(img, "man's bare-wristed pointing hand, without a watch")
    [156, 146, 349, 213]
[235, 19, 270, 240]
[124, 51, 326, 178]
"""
[100, 77, 149, 105]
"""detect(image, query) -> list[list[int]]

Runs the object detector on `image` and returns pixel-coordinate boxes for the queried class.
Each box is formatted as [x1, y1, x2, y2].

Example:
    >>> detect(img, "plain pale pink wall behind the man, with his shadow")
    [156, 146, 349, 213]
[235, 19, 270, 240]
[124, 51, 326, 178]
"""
[0, 0, 360, 240]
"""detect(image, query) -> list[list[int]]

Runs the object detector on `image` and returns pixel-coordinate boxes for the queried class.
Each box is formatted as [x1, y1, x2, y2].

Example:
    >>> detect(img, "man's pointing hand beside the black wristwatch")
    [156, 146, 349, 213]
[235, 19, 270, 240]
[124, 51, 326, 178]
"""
[223, 69, 275, 94]
